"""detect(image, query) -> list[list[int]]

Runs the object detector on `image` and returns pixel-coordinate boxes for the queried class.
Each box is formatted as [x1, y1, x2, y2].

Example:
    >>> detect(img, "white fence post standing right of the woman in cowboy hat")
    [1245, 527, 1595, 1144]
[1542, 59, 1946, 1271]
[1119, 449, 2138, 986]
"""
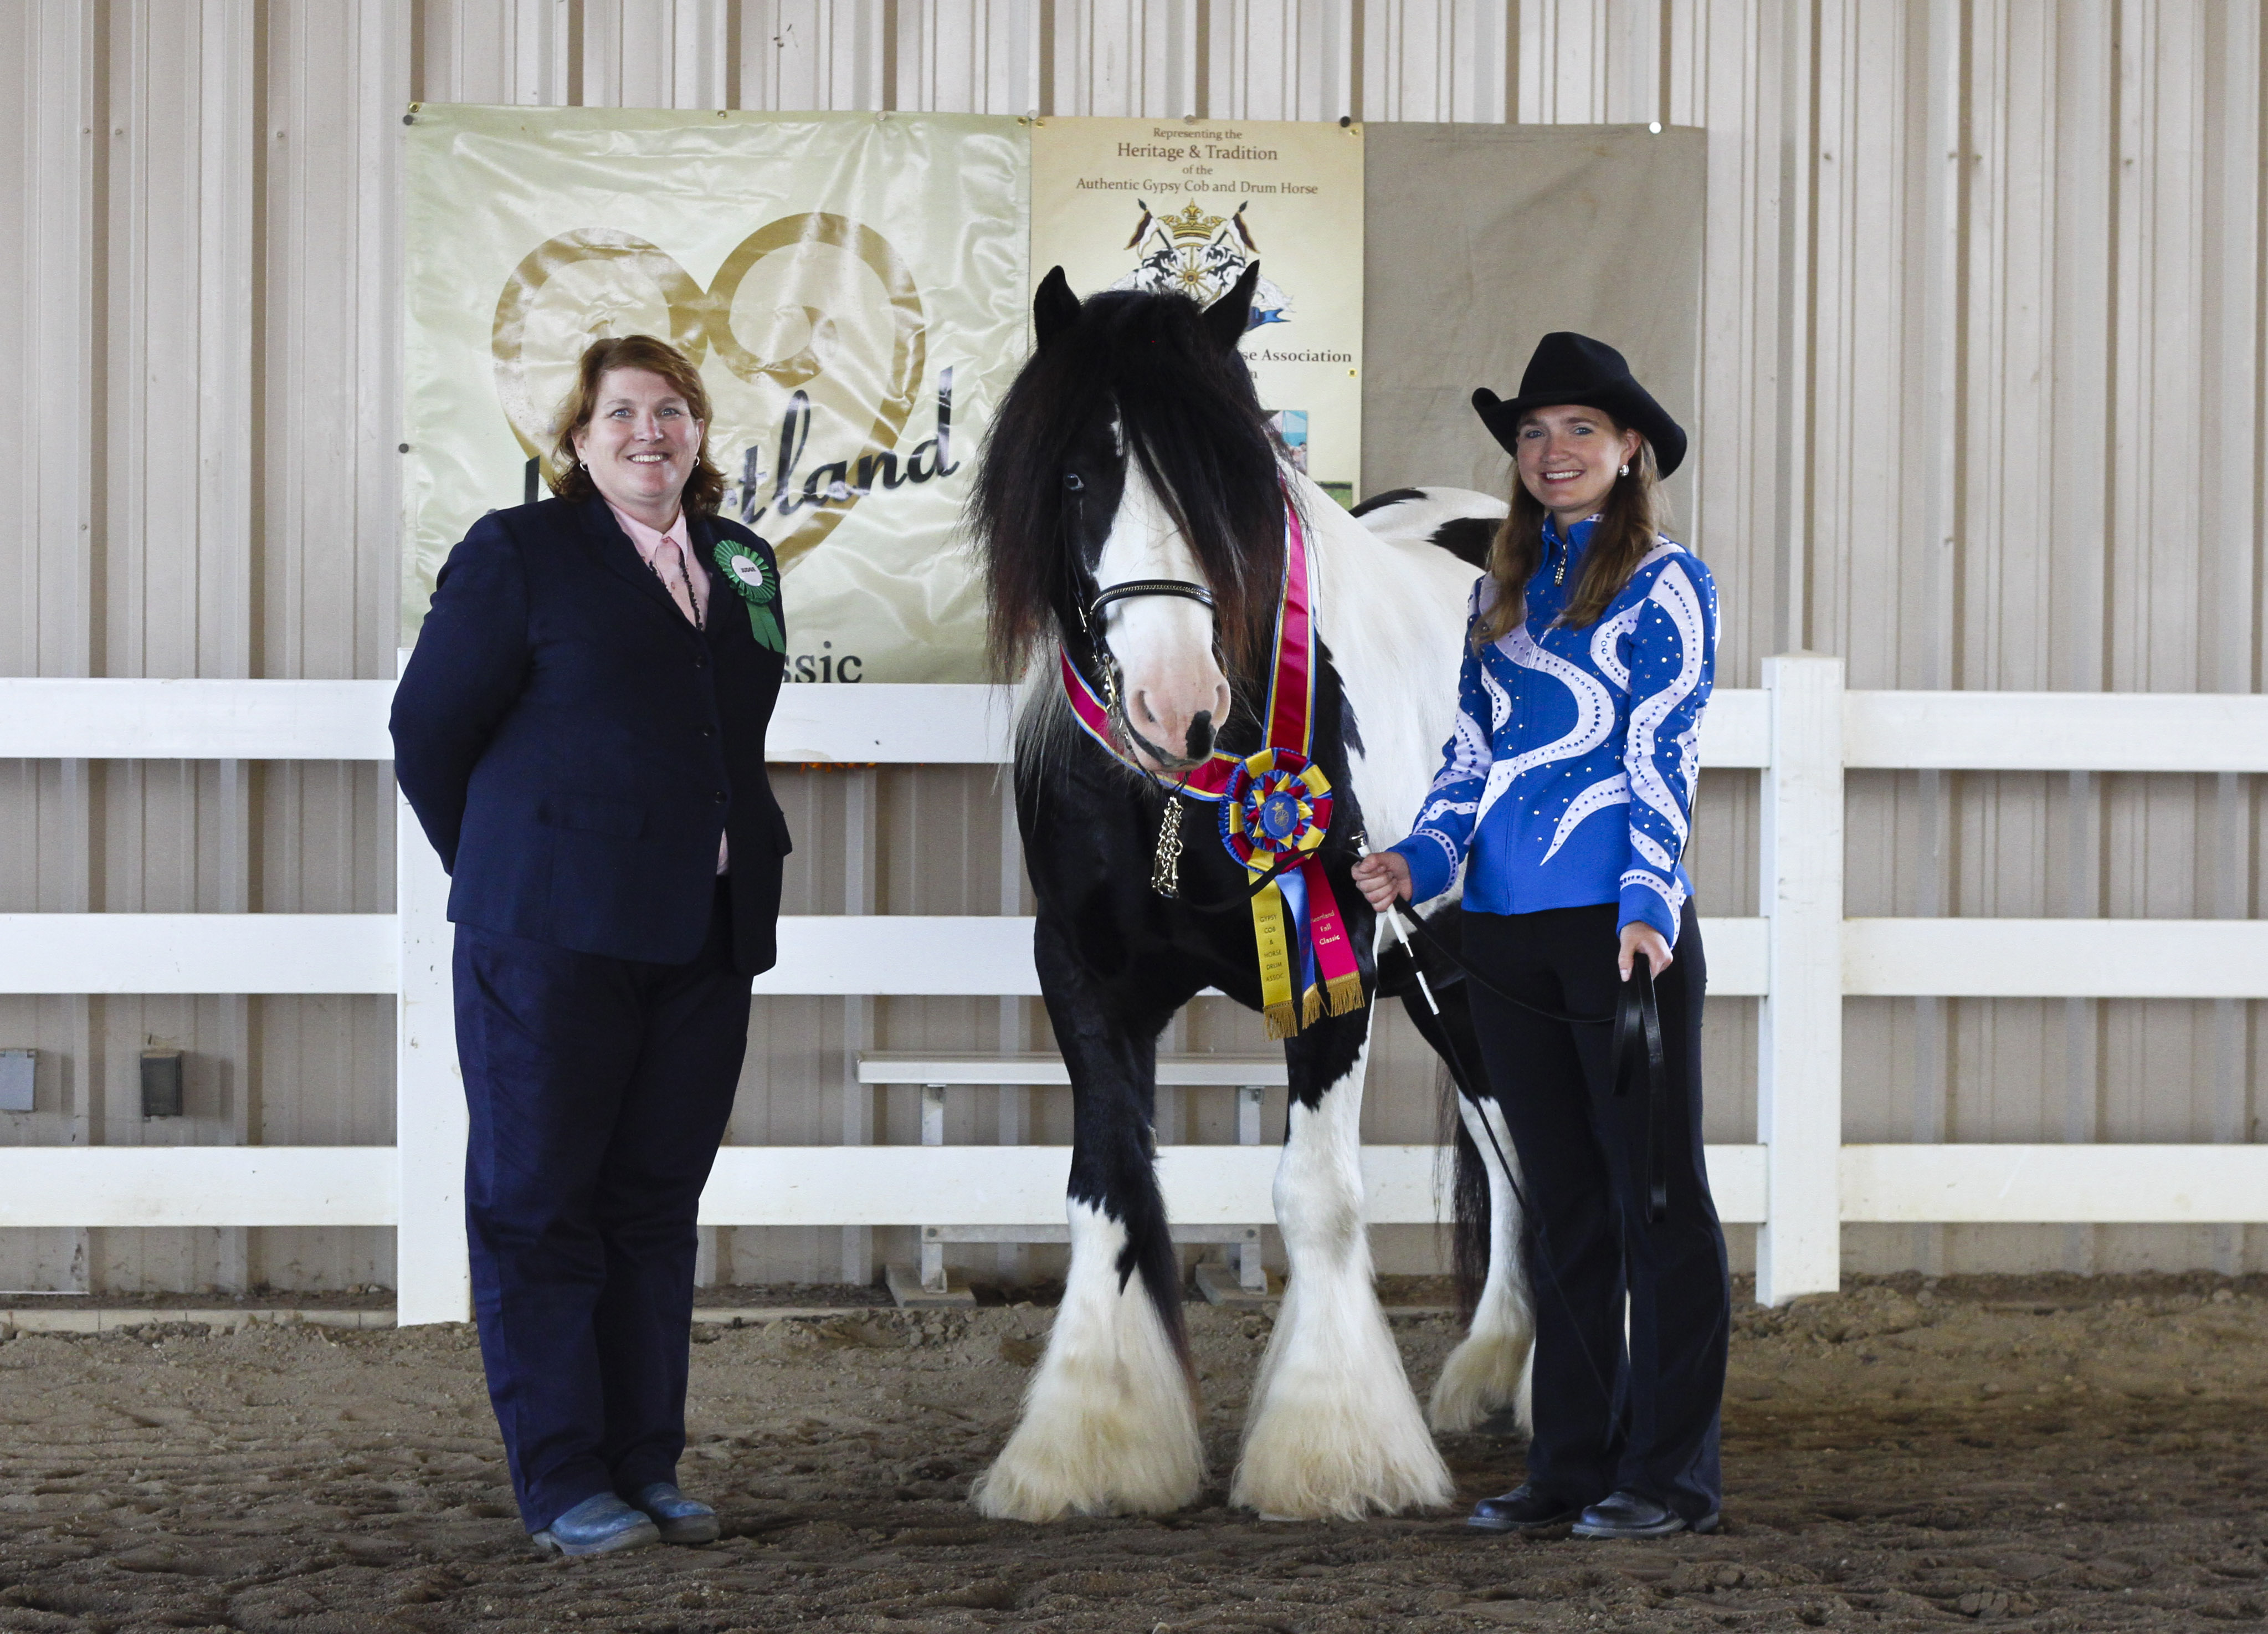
[1756, 654, 1844, 1305]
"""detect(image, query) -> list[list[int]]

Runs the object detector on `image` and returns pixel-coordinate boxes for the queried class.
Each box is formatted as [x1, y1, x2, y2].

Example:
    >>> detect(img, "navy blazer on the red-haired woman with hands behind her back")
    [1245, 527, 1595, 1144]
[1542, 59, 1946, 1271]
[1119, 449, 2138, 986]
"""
[392, 499, 789, 976]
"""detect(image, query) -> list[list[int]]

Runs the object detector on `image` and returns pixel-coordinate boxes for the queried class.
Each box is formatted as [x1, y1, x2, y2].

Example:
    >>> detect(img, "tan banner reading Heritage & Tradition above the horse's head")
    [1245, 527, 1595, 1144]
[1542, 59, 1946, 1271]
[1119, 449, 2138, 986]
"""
[1032, 118, 1363, 504]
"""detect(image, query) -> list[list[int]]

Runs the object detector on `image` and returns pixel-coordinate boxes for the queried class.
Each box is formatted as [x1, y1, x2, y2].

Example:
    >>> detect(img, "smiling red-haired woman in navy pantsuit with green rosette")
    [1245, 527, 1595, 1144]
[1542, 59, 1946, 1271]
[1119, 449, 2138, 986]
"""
[392, 336, 789, 1555]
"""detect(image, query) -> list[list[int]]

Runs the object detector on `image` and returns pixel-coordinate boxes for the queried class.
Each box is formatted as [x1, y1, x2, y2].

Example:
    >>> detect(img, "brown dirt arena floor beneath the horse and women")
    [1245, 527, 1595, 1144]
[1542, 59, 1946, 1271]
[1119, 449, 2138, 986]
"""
[0, 1278, 2268, 1634]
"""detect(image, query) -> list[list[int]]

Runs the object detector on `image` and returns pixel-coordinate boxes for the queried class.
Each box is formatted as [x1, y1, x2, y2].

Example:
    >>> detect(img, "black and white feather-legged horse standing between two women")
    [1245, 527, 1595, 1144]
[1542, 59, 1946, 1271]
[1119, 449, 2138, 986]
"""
[973, 268, 1528, 1520]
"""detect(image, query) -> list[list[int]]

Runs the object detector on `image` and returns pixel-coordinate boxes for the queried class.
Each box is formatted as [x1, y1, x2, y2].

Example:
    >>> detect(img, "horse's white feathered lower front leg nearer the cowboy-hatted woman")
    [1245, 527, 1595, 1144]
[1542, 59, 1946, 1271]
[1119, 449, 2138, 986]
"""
[1229, 1046, 1451, 1520]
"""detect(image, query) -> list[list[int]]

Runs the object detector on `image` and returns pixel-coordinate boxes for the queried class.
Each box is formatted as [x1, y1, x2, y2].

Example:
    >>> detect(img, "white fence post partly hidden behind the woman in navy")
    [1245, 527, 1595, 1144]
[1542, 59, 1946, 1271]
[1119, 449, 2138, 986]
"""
[394, 654, 472, 1328]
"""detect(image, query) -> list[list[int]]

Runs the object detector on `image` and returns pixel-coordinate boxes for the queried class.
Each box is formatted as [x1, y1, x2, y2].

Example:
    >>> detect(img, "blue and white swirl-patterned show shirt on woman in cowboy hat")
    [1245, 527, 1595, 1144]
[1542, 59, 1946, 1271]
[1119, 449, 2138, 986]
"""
[1393, 520, 1717, 942]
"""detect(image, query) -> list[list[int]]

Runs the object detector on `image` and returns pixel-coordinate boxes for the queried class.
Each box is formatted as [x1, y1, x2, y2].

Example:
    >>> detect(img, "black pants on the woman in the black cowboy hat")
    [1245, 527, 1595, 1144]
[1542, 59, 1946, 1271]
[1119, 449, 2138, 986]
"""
[1465, 901, 1733, 1520]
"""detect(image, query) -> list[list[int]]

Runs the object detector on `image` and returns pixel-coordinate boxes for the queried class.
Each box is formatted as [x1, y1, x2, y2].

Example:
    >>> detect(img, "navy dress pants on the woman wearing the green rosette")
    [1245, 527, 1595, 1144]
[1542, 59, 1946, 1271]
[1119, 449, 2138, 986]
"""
[454, 878, 748, 1532]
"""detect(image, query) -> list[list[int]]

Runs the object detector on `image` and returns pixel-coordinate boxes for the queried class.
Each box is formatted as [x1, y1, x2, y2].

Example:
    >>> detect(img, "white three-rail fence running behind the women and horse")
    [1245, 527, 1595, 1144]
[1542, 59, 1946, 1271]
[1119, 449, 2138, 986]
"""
[0, 654, 2268, 1323]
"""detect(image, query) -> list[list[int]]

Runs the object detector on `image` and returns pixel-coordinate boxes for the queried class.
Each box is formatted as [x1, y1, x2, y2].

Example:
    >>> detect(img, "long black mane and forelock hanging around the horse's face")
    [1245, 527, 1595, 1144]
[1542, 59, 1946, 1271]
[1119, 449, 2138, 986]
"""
[971, 290, 1284, 677]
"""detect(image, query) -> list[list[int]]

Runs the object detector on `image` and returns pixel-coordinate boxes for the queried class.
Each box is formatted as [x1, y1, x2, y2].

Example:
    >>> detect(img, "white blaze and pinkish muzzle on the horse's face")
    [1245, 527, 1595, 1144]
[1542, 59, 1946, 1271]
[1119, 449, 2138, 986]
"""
[1095, 456, 1229, 772]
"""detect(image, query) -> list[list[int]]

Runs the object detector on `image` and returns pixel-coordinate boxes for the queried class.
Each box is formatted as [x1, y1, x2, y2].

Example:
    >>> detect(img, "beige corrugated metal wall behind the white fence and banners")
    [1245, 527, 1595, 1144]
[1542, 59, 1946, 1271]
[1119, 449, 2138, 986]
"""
[0, 0, 2268, 1289]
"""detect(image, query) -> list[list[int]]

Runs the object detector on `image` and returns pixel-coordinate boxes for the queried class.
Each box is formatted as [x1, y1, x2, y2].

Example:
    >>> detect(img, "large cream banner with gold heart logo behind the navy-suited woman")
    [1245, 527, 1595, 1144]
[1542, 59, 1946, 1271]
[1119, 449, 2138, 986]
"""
[402, 104, 1029, 681]
